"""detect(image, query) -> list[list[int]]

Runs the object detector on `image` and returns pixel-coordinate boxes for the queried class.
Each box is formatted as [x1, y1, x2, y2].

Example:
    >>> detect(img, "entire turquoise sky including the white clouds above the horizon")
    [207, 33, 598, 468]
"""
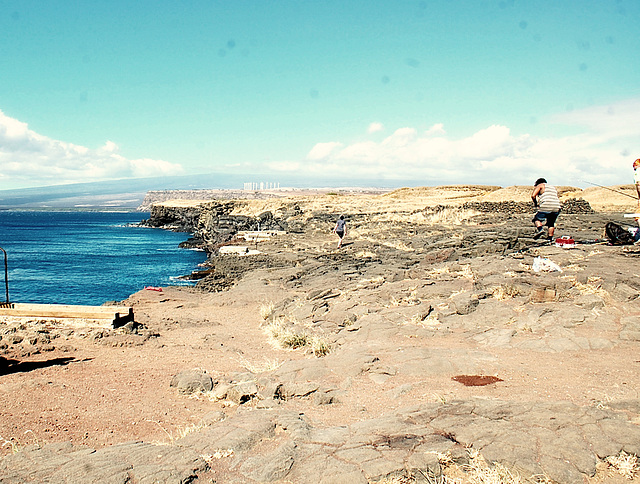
[0, 0, 640, 189]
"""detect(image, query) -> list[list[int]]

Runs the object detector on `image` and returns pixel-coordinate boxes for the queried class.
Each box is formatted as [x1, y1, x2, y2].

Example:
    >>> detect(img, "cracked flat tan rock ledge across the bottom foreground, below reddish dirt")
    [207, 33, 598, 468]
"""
[0, 399, 640, 484]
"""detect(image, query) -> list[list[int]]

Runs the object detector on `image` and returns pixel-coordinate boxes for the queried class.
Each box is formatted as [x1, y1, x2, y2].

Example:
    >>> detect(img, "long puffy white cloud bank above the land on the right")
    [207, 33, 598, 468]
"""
[302, 99, 640, 186]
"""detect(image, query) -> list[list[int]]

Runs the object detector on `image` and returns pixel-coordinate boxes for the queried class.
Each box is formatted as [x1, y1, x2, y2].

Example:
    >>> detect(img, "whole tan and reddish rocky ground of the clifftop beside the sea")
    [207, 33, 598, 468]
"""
[0, 187, 640, 483]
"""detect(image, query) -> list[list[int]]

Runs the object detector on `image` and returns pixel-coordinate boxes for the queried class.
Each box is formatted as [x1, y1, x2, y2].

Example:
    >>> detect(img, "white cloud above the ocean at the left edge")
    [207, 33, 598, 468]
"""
[0, 111, 183, 188]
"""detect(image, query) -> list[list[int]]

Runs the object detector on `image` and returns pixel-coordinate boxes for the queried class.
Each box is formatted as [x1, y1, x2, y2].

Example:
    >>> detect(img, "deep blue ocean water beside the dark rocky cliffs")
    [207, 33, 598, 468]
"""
[0, 211, 206, 305]
